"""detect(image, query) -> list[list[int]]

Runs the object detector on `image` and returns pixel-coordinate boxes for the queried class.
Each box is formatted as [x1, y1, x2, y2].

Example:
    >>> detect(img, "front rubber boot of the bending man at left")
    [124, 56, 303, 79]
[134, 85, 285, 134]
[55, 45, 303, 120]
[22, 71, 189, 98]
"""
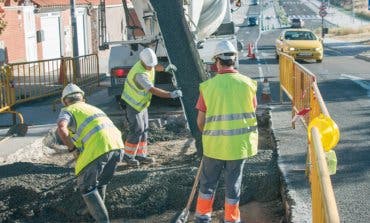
[82, 189, 109, 223]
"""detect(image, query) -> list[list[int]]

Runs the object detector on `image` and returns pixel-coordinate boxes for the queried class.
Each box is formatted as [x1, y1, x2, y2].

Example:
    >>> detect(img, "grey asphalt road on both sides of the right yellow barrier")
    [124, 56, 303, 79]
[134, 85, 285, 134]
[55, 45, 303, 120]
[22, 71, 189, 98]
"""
[238, 1, 370, 222]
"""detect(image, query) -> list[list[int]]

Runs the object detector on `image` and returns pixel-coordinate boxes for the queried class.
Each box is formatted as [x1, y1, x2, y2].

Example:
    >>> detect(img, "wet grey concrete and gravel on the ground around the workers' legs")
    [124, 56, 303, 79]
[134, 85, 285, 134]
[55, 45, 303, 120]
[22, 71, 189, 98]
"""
[0, 109, 283, 222]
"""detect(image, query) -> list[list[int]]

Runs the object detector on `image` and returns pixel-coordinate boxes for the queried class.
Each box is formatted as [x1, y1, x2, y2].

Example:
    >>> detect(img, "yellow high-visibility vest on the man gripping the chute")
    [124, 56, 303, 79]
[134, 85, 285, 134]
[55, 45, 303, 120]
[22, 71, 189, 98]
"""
[121, 61, 155, 112]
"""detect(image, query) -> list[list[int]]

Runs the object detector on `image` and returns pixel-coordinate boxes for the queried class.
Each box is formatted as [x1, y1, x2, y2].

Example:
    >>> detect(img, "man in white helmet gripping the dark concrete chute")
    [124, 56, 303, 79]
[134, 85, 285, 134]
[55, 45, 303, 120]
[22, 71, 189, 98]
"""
[121, 48, 182, 166]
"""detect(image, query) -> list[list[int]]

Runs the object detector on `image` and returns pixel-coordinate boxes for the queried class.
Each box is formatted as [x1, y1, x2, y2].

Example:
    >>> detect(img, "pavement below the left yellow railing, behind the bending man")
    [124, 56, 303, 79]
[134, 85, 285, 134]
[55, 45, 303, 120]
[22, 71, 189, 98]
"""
[0, 79, 120, 162]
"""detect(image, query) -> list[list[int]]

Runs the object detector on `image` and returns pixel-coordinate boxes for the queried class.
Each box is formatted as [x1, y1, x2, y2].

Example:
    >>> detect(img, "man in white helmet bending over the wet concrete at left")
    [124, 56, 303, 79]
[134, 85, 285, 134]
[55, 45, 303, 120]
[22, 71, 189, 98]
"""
[57, 84, 124, 222]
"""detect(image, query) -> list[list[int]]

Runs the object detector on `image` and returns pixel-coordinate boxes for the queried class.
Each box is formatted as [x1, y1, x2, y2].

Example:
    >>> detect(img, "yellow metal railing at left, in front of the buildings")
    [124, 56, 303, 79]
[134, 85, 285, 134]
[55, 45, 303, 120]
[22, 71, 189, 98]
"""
[0, 54, 100, 125]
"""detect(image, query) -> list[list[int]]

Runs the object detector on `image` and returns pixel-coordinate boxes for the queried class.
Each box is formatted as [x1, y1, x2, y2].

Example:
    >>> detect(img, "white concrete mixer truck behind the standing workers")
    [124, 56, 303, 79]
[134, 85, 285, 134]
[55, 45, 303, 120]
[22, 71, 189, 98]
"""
[99, 0, 240, 98]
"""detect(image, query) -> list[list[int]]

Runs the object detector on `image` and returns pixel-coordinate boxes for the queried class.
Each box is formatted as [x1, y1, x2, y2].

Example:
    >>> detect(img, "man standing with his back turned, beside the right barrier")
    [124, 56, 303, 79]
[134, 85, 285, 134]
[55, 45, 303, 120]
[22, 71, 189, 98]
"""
[195, 40, 258, 222]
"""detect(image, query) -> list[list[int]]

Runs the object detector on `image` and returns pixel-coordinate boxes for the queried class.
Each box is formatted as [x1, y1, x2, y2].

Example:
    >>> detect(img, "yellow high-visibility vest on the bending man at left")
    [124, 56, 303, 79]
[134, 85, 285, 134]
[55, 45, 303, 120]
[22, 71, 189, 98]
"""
[63, 102, 124, 175]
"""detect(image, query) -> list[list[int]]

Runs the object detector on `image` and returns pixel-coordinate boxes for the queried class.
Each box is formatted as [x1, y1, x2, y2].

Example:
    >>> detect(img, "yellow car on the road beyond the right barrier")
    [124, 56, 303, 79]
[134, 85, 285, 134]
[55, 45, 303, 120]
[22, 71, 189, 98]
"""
[276, 29, 324, 63]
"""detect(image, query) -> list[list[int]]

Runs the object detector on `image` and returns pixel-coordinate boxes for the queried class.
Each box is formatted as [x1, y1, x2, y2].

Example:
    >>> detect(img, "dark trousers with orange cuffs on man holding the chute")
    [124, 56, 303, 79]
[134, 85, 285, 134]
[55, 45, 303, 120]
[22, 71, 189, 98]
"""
[125, 104, 149, 157]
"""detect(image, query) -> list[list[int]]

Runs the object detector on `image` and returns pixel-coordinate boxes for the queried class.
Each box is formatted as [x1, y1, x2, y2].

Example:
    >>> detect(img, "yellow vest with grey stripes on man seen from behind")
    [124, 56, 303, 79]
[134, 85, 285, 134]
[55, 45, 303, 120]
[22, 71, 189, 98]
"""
[200, 73, 258, 160]
